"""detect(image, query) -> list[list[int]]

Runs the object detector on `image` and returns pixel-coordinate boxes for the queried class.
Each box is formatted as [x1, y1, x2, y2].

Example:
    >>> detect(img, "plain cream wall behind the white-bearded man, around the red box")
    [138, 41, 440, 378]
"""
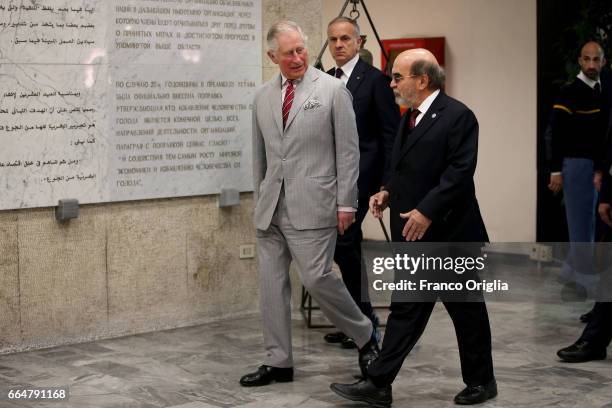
[320, 0, 537, 242]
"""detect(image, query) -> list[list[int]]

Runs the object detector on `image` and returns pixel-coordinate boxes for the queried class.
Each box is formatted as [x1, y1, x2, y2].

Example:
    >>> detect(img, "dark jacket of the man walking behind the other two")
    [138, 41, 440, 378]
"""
[327, 59, 400, 201]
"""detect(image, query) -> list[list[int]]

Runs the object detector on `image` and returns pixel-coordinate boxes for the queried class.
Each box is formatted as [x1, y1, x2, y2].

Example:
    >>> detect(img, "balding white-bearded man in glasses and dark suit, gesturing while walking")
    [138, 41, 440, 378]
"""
[331, 49, 497, 407]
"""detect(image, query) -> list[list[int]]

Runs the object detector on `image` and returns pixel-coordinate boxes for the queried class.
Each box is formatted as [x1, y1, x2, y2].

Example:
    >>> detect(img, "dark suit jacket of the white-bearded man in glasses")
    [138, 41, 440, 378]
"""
[386, 92, 488, 242]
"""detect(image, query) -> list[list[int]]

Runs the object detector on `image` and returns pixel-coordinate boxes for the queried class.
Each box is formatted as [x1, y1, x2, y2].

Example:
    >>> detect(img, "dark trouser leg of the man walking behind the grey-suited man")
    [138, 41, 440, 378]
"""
[334, 200, 378, 325]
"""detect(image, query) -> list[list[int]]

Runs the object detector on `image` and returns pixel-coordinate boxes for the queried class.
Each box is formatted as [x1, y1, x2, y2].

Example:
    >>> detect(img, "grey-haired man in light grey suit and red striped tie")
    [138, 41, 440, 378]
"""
[240, 21, 378, 386]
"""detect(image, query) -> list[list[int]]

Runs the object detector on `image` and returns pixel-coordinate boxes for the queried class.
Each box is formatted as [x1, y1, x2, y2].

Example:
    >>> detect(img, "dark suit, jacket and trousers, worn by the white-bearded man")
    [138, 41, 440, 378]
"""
[368, 92, 494, 386]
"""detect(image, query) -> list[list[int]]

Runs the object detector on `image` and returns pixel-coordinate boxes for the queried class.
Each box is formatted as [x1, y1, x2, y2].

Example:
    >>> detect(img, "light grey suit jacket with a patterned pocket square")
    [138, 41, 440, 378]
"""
[253, 67, 359, 230]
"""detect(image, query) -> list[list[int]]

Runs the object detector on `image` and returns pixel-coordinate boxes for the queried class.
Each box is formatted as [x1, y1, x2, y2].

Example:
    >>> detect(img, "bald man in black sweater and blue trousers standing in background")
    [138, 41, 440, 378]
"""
[548, 41, 608, 298]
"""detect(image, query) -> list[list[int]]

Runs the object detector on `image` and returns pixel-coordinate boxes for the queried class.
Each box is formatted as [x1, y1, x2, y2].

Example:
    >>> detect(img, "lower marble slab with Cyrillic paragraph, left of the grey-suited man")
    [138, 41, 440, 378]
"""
[104, 64, 261, 201]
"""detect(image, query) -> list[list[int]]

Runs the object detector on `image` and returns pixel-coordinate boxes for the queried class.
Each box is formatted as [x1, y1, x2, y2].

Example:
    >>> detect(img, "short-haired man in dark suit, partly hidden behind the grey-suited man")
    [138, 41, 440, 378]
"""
[325, 17, 400, 348]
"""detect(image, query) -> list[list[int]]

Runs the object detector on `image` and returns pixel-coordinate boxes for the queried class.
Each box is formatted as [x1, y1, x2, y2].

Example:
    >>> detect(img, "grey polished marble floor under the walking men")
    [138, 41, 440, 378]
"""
[0, 303, 612, 408]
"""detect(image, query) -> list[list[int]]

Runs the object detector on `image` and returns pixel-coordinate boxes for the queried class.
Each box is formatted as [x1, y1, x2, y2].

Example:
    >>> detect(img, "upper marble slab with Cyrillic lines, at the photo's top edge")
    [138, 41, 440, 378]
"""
[107, 0, 262, 69]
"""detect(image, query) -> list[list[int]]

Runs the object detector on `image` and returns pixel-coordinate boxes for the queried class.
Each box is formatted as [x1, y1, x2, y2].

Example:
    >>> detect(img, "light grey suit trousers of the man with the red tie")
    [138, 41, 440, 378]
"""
[257, 189, 373, 368]
